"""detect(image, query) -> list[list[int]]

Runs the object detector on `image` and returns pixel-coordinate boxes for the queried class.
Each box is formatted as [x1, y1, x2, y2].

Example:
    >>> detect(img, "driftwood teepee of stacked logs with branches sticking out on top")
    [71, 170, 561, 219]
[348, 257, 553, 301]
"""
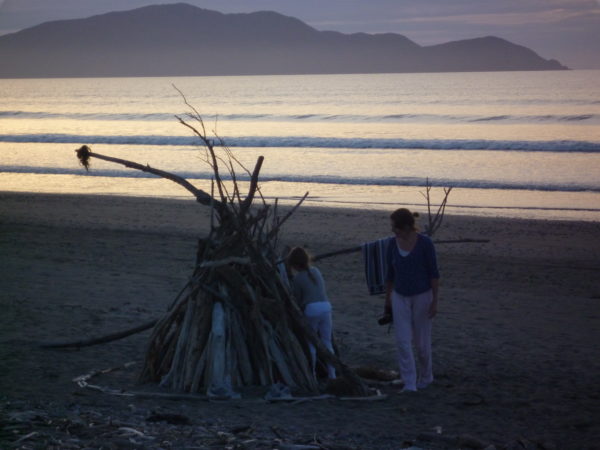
[77, 106, 367, 395]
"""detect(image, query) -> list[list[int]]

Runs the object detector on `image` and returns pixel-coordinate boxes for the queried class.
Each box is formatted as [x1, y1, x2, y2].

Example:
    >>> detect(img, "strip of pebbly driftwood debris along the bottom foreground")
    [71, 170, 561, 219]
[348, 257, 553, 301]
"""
[0, 397, 564, 450]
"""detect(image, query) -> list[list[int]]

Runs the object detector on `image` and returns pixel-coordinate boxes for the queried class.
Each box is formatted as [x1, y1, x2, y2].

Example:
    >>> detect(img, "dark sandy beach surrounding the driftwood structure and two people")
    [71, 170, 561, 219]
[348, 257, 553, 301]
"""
[0, 193, 600, 449]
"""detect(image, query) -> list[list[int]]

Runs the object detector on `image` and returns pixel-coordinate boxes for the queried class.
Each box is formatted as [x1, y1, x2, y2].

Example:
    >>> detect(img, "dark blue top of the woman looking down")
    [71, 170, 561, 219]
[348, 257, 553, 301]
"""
[386, 234, 440, 296]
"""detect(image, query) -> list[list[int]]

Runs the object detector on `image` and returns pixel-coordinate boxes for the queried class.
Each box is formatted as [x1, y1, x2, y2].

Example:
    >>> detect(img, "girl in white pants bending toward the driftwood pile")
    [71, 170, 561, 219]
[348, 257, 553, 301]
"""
[288, 247, 335, 379]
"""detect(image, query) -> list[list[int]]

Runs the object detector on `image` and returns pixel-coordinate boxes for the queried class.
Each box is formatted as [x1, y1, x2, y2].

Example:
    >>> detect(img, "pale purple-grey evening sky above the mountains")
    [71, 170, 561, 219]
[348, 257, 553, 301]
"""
[0, 0, 600, 69]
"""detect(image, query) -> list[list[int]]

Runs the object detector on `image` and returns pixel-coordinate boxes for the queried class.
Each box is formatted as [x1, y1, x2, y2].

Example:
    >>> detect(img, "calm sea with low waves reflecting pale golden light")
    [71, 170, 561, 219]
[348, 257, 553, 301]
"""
[0, 71, 600, 220]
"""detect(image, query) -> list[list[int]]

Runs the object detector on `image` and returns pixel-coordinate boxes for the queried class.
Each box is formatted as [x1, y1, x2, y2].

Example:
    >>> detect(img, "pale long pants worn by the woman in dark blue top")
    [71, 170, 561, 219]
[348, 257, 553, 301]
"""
[392, 290, 433, 390]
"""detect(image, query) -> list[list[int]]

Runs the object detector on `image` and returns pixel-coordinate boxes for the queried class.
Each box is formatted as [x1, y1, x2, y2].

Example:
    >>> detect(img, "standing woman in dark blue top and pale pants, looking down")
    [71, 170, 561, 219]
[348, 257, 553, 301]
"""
[385, 208, 440, 391]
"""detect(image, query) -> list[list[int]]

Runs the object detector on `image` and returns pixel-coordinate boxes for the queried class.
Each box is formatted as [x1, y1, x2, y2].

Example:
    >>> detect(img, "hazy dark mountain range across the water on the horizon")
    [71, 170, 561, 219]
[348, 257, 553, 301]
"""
[0, 3, 567, 78]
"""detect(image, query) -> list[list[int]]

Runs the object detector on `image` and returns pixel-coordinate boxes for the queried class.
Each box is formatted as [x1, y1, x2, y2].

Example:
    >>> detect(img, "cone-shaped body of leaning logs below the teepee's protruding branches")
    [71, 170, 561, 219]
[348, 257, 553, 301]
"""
[140, 232, 318, 392]
